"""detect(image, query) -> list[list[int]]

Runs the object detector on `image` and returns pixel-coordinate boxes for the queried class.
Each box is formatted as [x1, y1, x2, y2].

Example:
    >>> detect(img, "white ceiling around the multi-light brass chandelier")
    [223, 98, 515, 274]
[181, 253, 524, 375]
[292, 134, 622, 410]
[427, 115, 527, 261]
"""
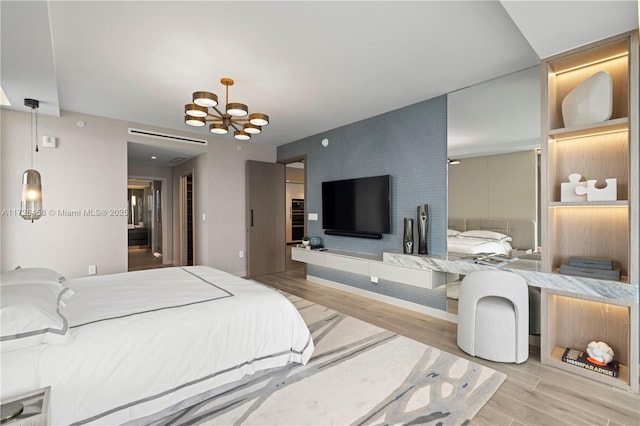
[0, 0, 638, 165]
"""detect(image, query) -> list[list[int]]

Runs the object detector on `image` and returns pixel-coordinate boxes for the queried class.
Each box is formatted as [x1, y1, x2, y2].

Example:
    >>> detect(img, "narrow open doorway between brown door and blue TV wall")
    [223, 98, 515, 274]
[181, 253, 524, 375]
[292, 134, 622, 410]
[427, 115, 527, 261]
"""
[285, 158, 306, 271]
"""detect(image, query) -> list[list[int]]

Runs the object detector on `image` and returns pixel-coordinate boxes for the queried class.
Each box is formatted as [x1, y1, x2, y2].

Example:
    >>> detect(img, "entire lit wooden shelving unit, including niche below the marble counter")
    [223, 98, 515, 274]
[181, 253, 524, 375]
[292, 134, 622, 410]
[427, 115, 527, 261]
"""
[541, 31, 639, 392]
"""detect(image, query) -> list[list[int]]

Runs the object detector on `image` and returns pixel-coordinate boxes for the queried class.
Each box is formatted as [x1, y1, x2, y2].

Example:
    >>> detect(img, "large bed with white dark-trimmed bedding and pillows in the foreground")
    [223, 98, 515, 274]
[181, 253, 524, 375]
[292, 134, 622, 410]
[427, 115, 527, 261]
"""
[1, 266, 314, 425]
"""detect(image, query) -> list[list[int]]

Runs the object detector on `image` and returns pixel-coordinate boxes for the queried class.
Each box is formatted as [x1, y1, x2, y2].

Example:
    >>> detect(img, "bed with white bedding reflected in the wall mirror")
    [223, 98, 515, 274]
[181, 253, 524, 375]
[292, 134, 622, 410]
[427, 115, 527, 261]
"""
[447, 218, 537, 256]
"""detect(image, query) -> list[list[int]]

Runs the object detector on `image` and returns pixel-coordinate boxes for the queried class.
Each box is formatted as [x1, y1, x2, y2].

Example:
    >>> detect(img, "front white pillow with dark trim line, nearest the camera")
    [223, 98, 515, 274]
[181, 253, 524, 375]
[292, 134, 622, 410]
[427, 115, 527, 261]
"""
[0, 283, 72, 352]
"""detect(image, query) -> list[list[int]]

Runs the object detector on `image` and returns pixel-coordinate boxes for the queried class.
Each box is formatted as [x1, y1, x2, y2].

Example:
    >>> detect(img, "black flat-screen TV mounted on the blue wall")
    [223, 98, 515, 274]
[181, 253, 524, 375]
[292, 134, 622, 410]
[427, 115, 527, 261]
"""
[322, 175, 391, 239]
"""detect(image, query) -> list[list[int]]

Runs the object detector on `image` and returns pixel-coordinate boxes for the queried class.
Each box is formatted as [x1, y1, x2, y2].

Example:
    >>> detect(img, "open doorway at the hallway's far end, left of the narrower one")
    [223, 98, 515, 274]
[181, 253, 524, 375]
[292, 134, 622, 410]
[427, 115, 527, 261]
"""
[127, 178, 163, 271]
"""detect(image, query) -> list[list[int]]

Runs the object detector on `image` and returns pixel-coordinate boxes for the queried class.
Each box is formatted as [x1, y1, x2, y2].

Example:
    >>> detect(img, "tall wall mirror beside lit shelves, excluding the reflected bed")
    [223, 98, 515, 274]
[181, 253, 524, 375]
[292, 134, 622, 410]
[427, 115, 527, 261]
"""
[447, 66, 540, 254]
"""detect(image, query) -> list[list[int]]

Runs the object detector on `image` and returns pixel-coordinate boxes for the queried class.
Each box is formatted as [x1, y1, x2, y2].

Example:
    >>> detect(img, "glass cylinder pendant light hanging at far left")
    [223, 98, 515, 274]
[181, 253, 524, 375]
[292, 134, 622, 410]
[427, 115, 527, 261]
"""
[20, 99, 42, 223]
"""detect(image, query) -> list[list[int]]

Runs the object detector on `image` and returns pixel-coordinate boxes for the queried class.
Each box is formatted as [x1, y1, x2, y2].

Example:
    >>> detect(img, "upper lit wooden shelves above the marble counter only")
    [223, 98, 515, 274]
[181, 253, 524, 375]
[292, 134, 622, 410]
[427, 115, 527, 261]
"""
[542, 32, 638, 284]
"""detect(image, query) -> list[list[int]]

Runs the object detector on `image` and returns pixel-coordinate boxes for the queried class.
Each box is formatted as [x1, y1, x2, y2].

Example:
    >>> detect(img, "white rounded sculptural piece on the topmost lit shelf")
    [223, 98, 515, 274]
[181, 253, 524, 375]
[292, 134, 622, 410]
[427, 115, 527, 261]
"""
[562, 71, 613, 127]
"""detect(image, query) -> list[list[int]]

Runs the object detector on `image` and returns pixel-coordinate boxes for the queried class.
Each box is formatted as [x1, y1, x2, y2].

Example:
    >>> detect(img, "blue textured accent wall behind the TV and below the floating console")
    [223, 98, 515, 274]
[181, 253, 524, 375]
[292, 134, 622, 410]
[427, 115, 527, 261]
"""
[277, 96, 447, 309]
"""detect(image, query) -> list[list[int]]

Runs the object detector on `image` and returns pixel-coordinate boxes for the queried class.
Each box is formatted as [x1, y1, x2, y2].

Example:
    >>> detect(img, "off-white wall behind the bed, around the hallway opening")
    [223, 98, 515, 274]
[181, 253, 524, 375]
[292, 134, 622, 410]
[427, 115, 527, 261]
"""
[0, 110, 276, 278]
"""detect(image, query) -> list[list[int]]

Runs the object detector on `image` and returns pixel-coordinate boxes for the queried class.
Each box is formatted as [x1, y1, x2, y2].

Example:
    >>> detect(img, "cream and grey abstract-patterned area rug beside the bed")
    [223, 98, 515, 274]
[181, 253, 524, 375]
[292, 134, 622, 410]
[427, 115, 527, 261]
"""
[154, 294, 506, 425]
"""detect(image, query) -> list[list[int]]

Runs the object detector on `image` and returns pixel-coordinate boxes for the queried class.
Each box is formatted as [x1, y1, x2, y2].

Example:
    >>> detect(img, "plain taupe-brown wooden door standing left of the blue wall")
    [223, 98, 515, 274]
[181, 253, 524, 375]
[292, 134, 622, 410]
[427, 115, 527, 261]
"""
[246, 160, 286, 277]
